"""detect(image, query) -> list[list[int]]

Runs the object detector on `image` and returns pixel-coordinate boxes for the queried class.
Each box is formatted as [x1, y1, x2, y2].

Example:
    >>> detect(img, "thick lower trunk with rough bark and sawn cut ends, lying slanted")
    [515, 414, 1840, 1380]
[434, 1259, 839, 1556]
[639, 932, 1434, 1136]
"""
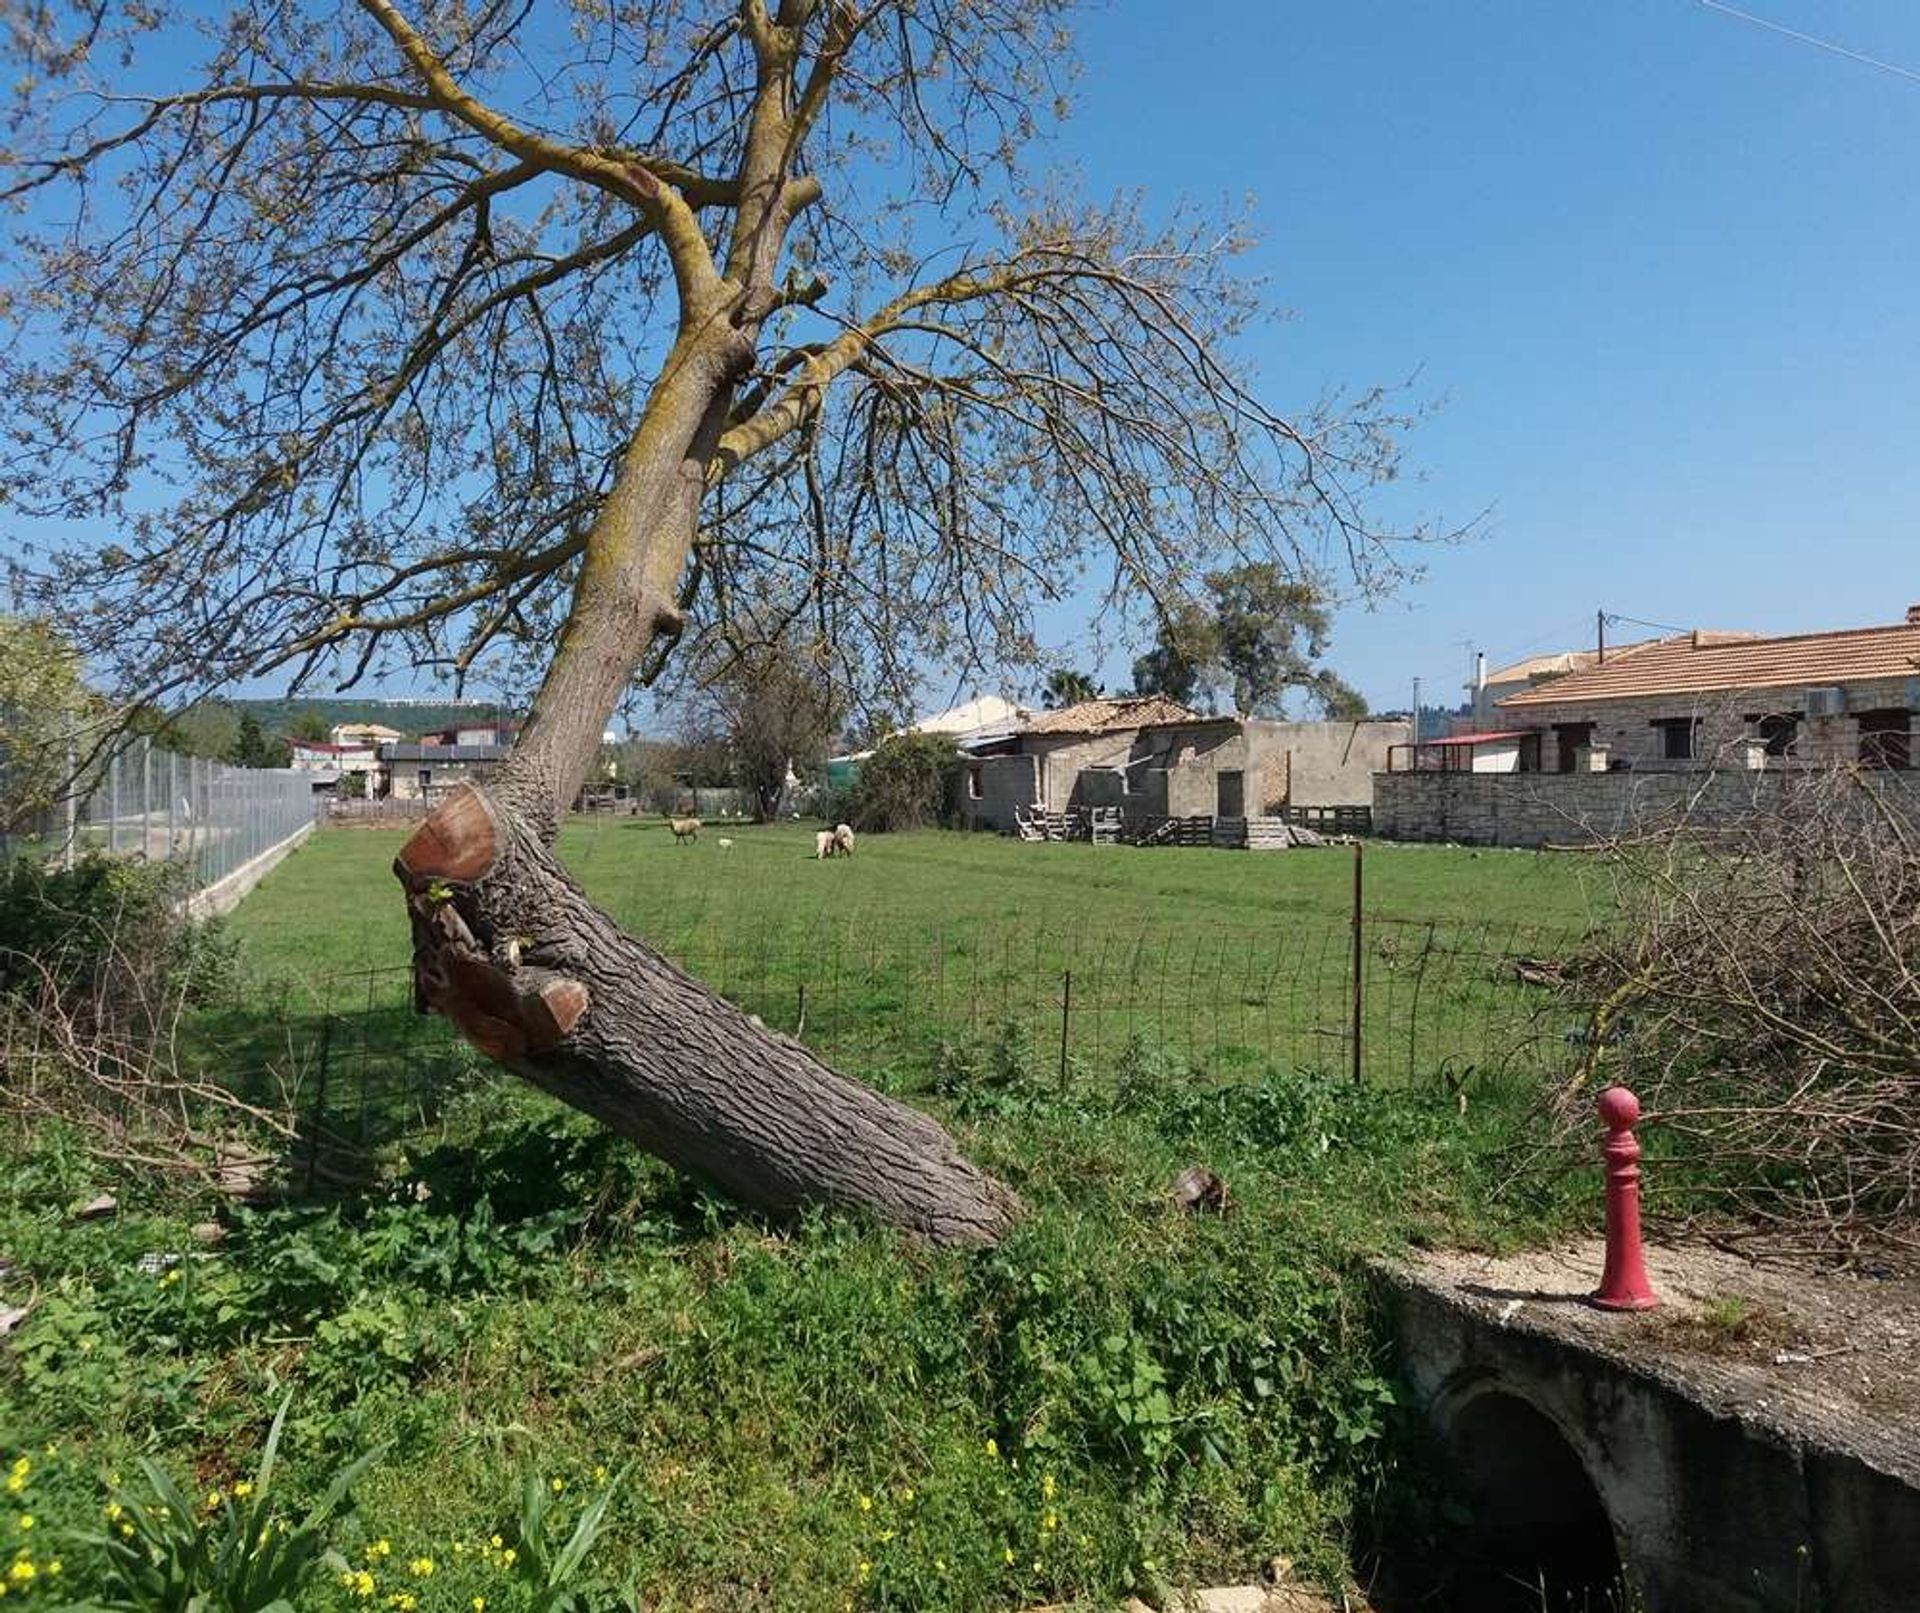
[394, 787, 1020, 1244]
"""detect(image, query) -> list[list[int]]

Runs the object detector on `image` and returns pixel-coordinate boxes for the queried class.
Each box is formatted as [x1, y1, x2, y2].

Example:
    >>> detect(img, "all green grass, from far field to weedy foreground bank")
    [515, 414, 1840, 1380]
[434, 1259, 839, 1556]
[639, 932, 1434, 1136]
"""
[0, 824, 1592, 1613]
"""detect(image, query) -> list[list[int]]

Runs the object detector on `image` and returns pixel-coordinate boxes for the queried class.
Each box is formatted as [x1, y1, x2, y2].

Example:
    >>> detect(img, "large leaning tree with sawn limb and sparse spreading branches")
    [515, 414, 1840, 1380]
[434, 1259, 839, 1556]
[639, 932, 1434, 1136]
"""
[0, 0, 1428, 1240]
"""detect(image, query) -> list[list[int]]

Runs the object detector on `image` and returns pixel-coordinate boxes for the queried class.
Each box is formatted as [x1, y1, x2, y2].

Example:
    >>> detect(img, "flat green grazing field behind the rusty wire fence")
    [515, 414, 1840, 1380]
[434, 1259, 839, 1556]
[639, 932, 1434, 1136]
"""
[232, 820, 1596, 1081]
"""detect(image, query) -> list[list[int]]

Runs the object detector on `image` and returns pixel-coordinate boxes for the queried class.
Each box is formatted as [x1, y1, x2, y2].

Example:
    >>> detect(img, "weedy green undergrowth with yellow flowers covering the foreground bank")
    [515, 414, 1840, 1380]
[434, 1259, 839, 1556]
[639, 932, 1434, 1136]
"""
[0, 1013, 1589, 1613]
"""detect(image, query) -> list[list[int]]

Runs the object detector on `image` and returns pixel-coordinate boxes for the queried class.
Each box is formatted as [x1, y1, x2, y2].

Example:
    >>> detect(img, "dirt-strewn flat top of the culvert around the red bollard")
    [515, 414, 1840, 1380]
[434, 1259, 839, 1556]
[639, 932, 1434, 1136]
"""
[1409, 1239, 1920, 1482]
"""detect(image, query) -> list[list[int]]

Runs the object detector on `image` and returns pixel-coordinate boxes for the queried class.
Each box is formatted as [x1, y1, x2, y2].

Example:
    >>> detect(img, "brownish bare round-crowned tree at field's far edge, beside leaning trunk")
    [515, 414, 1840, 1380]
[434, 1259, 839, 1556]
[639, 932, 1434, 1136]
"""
[695, 641, 841, 824]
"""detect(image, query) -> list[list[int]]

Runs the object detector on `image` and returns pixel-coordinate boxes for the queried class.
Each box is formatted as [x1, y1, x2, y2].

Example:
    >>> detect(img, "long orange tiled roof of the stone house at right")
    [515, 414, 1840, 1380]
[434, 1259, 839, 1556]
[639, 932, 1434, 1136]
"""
[1498, 622, 1920, 710]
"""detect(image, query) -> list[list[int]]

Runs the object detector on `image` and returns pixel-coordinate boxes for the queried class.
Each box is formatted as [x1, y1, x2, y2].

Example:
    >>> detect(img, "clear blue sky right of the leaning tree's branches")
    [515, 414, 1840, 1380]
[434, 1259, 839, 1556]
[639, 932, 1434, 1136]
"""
[1048, 0, 1920, 707]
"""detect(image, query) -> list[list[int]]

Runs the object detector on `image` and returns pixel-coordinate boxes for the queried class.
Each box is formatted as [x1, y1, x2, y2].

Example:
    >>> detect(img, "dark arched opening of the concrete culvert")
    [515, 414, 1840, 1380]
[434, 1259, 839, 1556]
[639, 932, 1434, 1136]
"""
[1440, 1392, 1622, 1613]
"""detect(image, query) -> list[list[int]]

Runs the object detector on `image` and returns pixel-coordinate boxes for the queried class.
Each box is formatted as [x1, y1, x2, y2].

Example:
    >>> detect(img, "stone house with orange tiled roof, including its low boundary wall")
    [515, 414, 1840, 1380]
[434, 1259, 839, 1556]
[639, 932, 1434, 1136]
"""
[1375, 605, 1920, 845]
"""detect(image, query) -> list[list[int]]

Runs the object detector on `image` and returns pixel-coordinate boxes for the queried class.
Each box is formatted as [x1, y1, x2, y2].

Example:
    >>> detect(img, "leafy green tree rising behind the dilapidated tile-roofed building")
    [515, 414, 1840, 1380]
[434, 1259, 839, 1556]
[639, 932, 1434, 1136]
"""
[1133, 561, 1367, 720]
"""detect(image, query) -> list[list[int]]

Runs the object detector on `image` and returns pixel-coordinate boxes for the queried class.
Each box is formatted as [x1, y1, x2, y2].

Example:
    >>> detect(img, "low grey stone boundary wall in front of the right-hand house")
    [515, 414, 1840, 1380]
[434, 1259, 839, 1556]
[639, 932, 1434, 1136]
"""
[1373, 768, 1920, 847]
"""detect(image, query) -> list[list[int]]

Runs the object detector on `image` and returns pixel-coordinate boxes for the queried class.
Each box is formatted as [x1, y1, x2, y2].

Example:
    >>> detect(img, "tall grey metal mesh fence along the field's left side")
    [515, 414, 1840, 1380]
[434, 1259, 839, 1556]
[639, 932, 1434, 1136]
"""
[0, 737, 315, 889]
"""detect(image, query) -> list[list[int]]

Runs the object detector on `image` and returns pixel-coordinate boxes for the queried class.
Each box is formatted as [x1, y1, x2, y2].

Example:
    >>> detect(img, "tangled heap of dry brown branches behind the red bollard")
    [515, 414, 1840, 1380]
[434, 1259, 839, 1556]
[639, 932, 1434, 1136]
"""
[1561, 770, 1920, 1248]
